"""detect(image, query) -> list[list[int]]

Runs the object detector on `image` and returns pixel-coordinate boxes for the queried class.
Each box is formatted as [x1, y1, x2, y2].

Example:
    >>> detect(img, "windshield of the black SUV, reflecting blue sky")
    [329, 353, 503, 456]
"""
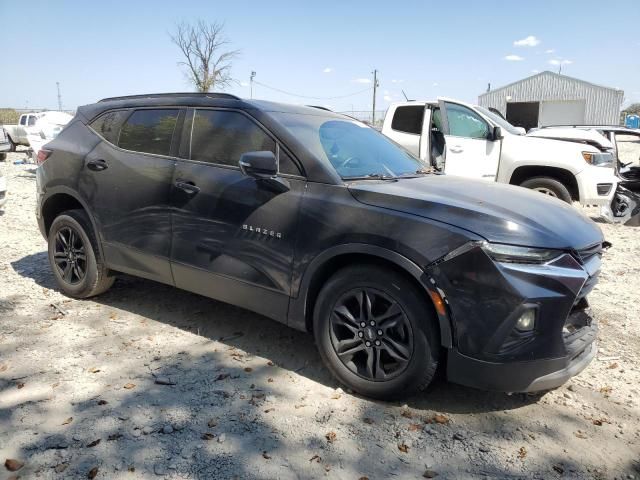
[271, 112, 429, 179]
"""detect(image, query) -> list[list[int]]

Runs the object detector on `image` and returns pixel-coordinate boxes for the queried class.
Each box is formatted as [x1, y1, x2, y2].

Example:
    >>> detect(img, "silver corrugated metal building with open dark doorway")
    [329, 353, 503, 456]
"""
[478, 71, 624, 130]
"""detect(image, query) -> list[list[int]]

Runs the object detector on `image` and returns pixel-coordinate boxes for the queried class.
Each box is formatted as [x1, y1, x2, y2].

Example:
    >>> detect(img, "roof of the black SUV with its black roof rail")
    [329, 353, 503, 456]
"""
[78, 93, 344, 120]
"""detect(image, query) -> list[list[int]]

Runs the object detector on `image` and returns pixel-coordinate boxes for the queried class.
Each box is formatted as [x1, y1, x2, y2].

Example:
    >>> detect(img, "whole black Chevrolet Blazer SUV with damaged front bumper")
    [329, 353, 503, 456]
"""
[37, 94, 603, 398]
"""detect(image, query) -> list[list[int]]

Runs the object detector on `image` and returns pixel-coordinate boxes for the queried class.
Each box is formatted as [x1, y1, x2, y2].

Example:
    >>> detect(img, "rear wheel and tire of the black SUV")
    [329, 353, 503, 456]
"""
[49, 210, 115, 298]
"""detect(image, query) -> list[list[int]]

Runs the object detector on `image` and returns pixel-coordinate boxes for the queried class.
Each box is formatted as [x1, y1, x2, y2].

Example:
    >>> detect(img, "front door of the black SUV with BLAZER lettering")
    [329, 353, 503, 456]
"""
[171, 109, 305, 320]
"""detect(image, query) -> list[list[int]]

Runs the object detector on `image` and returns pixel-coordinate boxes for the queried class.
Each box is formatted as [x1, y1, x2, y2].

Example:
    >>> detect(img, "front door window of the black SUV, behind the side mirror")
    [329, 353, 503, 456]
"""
[191, 110, 276, 166]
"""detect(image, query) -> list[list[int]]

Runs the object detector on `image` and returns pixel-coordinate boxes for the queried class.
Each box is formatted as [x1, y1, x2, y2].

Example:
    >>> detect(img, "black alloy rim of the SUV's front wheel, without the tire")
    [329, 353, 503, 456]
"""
[330, 288, 413, 381]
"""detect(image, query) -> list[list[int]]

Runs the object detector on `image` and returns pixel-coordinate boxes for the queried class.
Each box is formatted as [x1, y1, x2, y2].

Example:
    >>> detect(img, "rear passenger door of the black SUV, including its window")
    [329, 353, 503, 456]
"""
[79, 108, 184, 284]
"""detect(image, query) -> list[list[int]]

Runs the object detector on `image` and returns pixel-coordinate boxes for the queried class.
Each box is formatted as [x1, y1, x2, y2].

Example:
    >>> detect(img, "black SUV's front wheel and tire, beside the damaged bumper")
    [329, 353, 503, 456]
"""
[314, 265, 439, 400]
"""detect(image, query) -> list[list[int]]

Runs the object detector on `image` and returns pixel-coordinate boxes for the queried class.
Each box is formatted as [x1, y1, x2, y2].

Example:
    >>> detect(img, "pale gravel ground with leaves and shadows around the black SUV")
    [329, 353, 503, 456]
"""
[0, 152, 640, 480]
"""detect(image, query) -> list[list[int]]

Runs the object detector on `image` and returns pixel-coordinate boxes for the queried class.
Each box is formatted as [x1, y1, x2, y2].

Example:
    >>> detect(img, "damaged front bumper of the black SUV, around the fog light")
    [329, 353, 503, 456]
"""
[429, 244, 602, 392]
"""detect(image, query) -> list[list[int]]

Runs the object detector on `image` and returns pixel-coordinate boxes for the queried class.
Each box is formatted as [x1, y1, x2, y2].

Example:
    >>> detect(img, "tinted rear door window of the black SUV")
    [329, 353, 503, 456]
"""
[118, 109, 180, 155]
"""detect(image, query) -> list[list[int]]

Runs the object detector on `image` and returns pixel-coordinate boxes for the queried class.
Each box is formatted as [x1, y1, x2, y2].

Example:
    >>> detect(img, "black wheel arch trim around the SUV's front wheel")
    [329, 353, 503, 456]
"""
[287, 243, 453, 348]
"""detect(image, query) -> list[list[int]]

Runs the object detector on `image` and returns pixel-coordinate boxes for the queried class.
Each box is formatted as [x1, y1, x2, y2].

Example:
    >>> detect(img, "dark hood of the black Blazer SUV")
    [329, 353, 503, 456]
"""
[349, 175, 603, 250]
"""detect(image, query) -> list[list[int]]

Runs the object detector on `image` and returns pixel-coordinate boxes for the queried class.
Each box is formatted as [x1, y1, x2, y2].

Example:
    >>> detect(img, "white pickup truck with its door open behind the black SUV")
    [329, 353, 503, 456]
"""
[382, 98, 619, 205]
